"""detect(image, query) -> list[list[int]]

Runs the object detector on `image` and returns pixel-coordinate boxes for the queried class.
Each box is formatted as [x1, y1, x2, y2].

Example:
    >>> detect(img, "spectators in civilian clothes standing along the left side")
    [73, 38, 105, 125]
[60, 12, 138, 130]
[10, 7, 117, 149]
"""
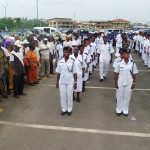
[0, 36, 55, 98]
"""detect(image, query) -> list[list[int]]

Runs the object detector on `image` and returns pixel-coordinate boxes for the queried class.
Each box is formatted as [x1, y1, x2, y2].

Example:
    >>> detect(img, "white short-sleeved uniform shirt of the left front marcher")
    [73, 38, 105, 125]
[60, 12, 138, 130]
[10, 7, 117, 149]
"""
[56, 58, 77, 84]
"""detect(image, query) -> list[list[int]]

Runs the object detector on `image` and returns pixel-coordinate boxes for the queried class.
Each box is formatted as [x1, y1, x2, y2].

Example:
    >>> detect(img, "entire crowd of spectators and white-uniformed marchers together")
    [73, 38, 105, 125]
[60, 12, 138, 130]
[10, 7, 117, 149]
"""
[0, 29, 150, 116]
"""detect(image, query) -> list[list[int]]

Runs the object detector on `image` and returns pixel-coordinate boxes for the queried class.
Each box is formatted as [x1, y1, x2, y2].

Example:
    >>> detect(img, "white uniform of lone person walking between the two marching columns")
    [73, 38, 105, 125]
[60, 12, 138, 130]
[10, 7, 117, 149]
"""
[97, 42, 114, 79]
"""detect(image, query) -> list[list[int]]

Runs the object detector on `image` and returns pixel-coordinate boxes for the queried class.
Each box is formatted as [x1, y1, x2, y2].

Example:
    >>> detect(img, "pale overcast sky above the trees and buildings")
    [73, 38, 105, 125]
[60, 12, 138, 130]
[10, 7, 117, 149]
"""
[0, 0, 150, 23]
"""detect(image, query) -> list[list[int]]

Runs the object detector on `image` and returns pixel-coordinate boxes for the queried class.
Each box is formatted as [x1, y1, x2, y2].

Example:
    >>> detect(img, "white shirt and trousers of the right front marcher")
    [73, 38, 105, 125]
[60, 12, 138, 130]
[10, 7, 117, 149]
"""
[115, 59, 138, 114]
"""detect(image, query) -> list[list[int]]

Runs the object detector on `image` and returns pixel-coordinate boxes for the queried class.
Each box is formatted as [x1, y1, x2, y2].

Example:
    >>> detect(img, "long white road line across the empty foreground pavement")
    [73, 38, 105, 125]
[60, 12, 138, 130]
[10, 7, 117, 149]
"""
[0, 121, 150, 138]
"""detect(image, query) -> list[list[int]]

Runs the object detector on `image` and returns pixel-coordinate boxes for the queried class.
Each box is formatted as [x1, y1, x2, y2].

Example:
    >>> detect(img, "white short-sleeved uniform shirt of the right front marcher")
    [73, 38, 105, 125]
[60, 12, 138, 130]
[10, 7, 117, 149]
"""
[115, 60, 138, 86]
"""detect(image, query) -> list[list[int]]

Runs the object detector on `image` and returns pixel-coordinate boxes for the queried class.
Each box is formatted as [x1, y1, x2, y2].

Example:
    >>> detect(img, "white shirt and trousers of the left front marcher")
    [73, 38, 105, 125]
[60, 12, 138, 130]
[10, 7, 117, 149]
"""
[56, 58, 77, 112]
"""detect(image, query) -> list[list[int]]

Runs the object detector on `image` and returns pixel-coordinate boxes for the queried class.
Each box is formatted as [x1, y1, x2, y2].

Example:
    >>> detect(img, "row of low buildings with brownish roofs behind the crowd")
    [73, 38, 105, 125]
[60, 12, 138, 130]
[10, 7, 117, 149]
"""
[49, 18, 131, 31]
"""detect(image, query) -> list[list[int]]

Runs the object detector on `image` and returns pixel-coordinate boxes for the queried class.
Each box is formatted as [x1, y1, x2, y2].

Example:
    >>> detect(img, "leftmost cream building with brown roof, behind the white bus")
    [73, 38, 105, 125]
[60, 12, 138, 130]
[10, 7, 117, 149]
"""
[49, 18, 74, 29]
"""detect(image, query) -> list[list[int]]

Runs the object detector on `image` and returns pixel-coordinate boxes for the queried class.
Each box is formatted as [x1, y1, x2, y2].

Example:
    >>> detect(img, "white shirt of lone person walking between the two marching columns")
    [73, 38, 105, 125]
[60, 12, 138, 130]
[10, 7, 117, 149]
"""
[97, 42, 114, 61]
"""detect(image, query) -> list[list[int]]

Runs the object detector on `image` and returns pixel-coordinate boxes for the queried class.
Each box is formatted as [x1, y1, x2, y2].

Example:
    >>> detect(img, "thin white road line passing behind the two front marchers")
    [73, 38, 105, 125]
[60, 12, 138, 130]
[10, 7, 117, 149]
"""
[39, 84, 150, 91]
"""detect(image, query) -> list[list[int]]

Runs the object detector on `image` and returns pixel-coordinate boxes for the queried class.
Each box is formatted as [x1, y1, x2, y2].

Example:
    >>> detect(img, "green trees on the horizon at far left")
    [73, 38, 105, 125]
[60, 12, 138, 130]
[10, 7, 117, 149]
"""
[0, 18, 48, 31]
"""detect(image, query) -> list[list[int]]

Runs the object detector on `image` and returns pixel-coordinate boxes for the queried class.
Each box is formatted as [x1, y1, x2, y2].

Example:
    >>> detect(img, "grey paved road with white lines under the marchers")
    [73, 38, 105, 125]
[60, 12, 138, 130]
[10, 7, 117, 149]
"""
[0, 52, 150, 150]
